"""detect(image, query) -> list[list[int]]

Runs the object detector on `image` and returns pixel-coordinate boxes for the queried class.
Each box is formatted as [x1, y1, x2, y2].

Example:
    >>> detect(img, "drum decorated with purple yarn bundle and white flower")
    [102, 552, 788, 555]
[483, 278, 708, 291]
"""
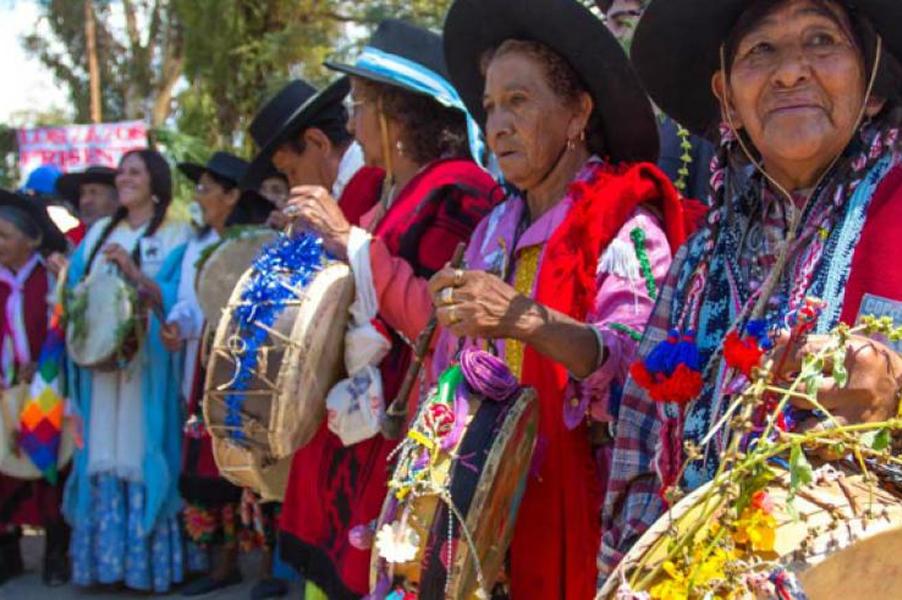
[370, 349, 538, 598]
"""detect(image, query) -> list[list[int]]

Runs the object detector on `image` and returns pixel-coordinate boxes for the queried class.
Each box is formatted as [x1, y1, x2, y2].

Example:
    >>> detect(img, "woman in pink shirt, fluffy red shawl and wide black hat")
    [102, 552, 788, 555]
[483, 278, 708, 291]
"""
[430, 0, 684, 599]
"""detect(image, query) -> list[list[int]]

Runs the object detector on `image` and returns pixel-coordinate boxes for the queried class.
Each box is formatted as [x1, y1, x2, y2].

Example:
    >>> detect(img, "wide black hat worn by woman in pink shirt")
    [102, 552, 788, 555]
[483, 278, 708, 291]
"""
[444, 0, 658, 162]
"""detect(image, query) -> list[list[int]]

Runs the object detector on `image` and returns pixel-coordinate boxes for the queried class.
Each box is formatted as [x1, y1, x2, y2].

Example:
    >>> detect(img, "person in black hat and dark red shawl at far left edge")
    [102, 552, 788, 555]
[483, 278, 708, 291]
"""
[0, 190, 69, 585]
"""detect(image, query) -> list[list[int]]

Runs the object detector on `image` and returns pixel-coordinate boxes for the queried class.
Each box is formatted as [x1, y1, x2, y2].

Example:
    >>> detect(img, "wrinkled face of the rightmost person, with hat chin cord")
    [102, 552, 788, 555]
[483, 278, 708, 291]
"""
[714, 0, 866, 177]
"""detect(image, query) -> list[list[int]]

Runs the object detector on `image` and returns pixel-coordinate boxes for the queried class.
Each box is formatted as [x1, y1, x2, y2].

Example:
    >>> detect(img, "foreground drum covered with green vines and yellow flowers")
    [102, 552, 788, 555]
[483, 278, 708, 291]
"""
[598, 298, 902, 600]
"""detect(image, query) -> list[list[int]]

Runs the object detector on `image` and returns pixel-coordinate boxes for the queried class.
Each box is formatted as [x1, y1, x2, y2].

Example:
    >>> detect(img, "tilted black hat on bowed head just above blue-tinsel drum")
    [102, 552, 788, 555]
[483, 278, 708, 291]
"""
[245, 77, 351, 187]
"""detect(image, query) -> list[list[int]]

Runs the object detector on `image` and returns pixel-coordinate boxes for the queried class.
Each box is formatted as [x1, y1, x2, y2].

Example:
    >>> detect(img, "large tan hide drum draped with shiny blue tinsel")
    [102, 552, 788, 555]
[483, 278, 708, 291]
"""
[203, 234, 354, 500]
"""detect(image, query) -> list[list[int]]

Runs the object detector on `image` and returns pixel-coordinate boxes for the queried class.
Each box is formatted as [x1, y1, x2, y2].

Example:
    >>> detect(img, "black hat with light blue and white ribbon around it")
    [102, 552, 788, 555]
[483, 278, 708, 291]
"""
[323, 19, 448, 94]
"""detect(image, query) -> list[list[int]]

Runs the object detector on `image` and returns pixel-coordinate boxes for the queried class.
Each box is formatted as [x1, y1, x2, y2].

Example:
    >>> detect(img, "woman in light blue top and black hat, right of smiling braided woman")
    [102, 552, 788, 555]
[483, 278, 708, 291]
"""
[161, 152, 273, 596]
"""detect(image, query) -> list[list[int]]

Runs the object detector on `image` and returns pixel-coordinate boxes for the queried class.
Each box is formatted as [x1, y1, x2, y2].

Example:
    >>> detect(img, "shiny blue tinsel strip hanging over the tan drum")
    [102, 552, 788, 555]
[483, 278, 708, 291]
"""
[225, 234, 328, 442]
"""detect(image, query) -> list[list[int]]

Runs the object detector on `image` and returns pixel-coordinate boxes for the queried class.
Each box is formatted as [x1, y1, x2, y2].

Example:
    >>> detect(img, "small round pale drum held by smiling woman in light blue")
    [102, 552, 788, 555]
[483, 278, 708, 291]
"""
[66, 269, 138, 371]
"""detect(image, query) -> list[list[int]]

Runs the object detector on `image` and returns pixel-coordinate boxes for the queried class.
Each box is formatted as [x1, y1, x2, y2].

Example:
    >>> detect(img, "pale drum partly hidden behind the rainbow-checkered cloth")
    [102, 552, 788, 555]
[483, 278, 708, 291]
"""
[0, 383, 75, 479]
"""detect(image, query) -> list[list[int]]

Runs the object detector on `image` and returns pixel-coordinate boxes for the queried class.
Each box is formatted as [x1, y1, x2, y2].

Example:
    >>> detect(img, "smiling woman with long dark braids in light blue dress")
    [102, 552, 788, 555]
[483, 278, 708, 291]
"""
[65, 150, 190, 592]
